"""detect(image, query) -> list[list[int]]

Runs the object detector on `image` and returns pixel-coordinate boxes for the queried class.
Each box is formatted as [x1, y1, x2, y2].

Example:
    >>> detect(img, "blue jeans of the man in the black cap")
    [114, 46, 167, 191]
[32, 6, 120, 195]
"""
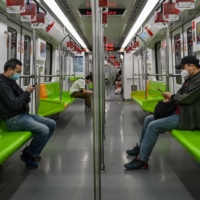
[138, 114, 179, 162]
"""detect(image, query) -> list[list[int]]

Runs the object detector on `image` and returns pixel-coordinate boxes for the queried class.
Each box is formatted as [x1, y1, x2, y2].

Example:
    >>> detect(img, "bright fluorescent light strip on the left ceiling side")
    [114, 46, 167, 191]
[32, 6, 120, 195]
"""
[43, 0, 87, 49]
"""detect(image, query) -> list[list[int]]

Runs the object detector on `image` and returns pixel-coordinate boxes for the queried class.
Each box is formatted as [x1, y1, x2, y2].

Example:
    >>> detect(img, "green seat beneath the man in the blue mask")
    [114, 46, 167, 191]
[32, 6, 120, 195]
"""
[0, 119, 32, 165]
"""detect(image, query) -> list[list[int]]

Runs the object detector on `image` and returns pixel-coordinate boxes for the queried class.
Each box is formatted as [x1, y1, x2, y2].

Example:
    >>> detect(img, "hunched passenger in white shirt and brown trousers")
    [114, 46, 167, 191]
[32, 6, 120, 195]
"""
[70, 75, 93, 113]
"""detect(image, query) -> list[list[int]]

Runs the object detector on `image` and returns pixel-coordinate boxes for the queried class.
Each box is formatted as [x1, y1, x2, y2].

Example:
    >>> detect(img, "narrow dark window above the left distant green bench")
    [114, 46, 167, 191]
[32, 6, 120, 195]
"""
[45, 43, 53, 82]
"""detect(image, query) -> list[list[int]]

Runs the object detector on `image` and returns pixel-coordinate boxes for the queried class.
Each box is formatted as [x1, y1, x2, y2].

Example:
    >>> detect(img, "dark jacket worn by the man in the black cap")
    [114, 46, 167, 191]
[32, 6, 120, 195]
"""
[172, 72, 200, 130]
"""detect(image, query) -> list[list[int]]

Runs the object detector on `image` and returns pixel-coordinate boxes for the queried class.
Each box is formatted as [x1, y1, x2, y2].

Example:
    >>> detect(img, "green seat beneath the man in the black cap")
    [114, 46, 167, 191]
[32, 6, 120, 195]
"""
[171, 130, 200, 163]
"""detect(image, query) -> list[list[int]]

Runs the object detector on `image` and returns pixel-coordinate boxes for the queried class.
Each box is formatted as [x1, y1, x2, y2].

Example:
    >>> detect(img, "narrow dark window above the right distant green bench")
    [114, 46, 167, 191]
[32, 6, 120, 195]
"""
[155, 42, 163, 81]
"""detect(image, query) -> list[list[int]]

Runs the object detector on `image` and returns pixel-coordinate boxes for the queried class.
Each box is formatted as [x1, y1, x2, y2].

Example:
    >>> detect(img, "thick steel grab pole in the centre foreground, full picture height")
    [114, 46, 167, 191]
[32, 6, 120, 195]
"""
[91, 0, 102, 200]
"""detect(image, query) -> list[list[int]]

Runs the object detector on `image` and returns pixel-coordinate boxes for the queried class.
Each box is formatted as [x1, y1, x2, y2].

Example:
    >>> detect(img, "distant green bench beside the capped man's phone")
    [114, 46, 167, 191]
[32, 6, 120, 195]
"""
[131, 81, 166, 113]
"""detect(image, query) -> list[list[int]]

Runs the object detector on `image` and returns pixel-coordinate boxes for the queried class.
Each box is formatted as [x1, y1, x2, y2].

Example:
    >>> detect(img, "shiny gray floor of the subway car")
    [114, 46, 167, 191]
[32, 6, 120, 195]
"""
[0, 100, 200, 200]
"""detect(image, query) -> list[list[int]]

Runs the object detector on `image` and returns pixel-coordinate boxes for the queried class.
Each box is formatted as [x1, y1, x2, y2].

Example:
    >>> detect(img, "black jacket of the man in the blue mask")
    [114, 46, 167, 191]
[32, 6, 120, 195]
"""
[0, 74, 31, 119]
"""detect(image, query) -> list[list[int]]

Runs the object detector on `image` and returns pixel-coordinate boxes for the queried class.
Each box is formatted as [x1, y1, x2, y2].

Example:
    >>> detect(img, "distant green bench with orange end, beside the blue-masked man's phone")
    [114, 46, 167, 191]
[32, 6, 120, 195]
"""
[38, 82, 75, 116]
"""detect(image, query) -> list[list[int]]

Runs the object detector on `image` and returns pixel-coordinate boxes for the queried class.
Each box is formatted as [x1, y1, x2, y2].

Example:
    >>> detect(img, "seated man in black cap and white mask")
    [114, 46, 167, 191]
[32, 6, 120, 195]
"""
[124, 56, 200, 170]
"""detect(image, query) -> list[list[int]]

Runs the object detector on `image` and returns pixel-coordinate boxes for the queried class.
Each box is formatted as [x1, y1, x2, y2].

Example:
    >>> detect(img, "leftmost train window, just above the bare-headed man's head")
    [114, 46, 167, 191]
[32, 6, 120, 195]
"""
[7, 27, 17, 59]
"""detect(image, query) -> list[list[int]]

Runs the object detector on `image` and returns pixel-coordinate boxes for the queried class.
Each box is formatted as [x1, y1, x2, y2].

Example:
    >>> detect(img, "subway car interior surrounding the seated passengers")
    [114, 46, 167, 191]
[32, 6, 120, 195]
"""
[0, 0, 200, 200]
